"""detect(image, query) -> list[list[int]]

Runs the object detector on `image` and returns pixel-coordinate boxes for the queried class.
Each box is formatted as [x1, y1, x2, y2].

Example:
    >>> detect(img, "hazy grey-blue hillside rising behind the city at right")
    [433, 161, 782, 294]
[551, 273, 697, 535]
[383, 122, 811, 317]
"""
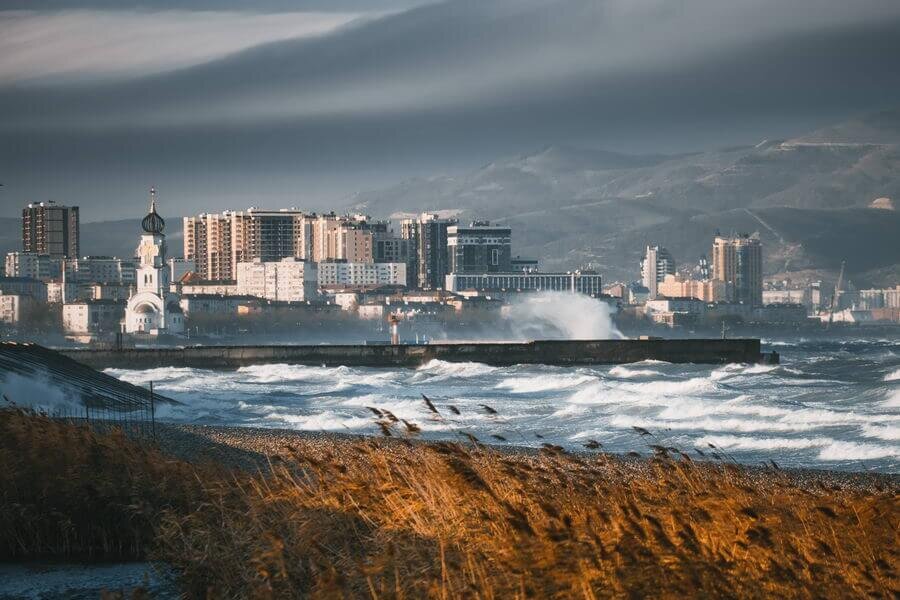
[351, 110, 900, 284]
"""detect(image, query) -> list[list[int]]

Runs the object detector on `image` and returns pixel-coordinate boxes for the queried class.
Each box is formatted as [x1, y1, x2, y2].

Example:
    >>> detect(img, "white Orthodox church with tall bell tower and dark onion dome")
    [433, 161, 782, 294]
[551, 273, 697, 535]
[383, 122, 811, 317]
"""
[125, 188, 184, 336]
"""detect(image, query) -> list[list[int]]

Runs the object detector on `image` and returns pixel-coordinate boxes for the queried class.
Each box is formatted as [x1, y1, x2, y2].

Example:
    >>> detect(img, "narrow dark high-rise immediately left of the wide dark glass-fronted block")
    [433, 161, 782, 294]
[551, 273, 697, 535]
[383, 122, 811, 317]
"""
[400, 213, 457, 290]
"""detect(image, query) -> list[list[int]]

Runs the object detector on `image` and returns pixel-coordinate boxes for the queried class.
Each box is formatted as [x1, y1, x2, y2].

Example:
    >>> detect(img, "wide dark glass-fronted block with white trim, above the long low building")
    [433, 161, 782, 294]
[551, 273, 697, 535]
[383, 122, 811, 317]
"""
[447, 221, 512, 274]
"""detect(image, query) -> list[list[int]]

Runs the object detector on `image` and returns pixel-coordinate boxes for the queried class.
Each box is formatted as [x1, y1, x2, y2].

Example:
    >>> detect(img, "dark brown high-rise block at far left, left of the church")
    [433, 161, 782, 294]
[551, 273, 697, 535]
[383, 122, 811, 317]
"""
[22, 202, 79, 258]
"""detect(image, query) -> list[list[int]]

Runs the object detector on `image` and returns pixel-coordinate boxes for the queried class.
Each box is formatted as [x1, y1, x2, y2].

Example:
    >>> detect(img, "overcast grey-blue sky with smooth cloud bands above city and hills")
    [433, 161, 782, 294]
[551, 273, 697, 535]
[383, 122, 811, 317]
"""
[0, 0, 900, 221]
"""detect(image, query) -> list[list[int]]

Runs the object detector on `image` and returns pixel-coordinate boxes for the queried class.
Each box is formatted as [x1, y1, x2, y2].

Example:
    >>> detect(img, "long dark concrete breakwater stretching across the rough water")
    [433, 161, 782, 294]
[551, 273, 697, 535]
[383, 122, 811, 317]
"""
[61, 339, 778, 369]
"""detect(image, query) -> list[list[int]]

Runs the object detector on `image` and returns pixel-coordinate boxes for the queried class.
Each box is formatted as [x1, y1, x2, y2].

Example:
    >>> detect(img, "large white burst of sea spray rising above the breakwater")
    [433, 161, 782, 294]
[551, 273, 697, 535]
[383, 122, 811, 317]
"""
[506, 292, 625, 340]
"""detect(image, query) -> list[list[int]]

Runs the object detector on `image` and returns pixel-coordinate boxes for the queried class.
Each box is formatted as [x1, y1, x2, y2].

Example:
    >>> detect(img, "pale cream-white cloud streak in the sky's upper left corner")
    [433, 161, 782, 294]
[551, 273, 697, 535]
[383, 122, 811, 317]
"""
[0, 10, 362, 86]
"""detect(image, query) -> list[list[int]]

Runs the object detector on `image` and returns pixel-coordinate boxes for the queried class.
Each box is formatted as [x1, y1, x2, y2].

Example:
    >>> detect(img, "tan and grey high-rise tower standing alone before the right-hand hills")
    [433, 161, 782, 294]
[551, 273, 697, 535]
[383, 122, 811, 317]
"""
[712, 235, 762, 306]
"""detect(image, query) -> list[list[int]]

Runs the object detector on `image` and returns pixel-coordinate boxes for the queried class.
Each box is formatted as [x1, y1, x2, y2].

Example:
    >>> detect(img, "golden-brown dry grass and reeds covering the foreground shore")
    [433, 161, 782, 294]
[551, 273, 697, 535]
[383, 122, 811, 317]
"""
[0, 406, 900, 599]
